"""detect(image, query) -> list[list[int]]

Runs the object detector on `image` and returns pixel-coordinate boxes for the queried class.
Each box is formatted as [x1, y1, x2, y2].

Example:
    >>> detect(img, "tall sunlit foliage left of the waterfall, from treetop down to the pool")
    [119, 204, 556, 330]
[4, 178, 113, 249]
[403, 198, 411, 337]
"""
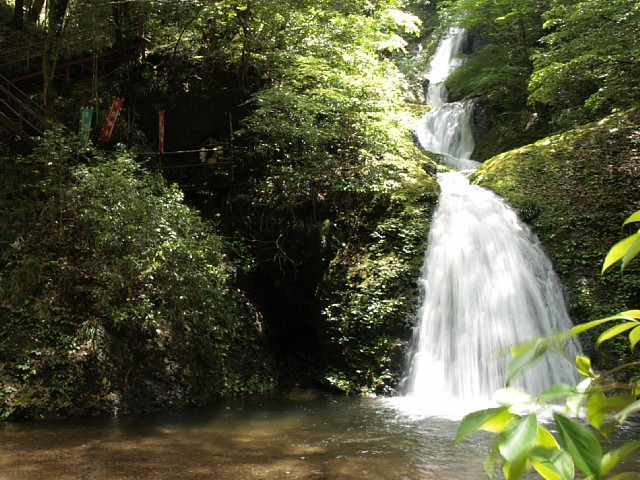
[229, 2, 436, 392]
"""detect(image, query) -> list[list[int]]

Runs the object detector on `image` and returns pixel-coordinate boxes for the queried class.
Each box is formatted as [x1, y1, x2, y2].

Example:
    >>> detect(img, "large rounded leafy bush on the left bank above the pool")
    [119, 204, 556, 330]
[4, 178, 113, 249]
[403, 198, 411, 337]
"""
[0, 134, 272, 416]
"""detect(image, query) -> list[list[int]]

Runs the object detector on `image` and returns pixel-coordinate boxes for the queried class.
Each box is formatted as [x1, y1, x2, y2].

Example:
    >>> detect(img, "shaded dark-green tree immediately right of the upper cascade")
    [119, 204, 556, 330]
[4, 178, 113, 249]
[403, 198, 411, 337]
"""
[439, 0, 549, 159]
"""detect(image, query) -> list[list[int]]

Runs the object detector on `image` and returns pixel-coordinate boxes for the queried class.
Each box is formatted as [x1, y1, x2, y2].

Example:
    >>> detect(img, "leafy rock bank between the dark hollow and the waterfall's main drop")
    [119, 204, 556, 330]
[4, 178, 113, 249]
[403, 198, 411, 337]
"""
[318, 150, 439, 393]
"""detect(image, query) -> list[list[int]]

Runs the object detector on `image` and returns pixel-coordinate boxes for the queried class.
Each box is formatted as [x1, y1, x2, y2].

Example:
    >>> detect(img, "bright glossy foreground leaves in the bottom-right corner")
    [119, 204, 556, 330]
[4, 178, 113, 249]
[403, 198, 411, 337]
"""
[455, 212, 640, 480]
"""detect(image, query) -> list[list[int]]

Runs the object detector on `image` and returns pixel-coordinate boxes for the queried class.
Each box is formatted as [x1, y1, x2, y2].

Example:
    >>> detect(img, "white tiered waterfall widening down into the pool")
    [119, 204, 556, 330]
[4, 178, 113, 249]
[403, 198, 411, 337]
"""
[402, 29, 577, 414]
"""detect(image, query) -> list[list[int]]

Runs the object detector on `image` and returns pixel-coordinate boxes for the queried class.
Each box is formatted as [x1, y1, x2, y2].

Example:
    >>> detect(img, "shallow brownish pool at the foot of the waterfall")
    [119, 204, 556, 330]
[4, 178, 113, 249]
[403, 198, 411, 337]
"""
[0, 395, 640, 480]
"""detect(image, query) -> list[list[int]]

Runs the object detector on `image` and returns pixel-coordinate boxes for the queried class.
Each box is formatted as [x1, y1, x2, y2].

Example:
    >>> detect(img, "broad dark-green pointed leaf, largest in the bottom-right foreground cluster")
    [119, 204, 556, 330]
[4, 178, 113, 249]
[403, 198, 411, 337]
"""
[553, 413, 602, 476]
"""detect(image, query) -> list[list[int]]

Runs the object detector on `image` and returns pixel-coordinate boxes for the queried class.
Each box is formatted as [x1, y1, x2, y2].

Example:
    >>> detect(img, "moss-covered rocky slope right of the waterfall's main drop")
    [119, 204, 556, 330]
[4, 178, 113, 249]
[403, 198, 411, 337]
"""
[473, 108, 640, 367]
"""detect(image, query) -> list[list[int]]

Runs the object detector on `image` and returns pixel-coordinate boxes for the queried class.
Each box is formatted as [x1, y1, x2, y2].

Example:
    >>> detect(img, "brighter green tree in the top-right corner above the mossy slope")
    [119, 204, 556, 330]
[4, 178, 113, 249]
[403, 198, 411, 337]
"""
[529, 0, 640, 127]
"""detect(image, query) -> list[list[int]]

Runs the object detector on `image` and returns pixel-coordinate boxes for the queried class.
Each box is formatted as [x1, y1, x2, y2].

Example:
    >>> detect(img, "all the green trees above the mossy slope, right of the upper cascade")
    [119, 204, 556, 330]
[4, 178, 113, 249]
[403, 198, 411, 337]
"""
[430, 0, 640, 159]
